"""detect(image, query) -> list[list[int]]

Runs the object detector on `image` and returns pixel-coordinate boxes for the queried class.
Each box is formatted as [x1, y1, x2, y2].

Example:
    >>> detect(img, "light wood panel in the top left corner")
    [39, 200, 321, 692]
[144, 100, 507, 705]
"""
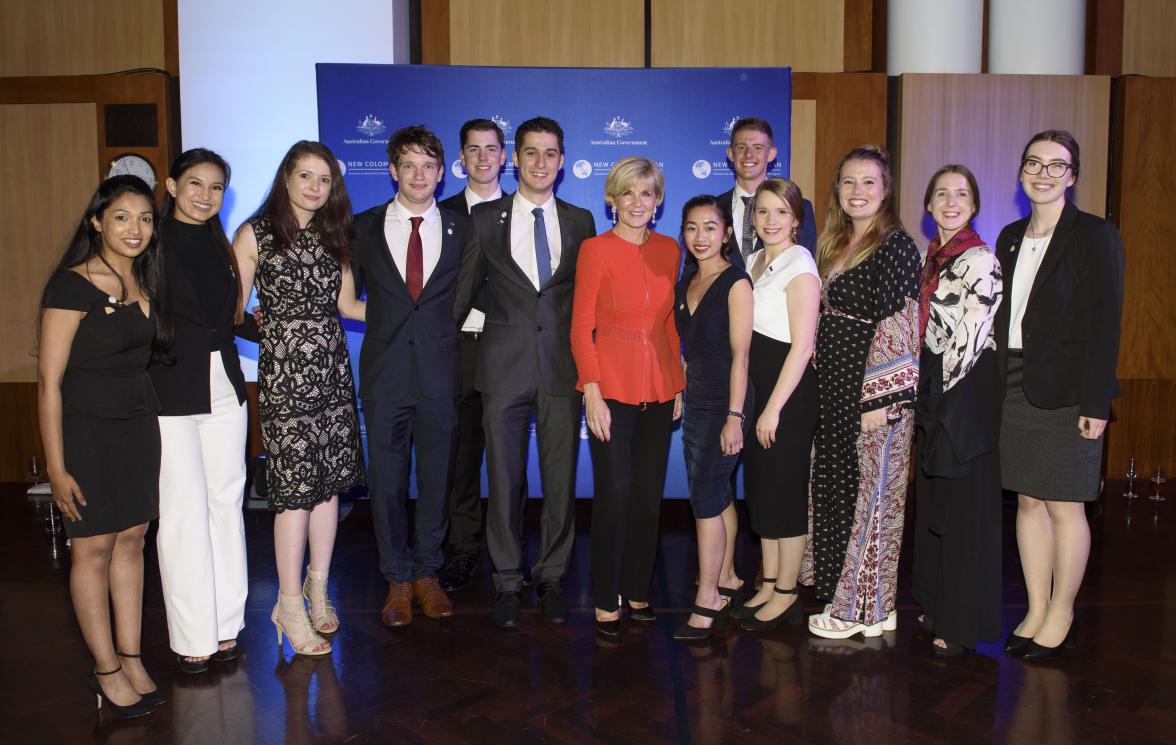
[0, 0, 171, 76]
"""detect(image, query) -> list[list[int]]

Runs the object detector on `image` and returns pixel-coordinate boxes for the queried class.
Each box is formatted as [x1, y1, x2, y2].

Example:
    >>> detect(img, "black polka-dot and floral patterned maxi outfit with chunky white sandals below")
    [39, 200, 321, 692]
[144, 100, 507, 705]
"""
[801, 230, 921, 625]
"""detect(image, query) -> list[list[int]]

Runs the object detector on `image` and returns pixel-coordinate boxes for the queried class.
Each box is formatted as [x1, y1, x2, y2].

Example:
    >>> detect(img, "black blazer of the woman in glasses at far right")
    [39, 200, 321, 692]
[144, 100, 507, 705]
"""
[996, 202, 1123, 420]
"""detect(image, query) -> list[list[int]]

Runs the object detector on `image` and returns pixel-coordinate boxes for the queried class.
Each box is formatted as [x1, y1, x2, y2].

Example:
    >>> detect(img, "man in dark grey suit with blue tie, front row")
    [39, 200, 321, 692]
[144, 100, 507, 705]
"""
[457, 118, 596, 627]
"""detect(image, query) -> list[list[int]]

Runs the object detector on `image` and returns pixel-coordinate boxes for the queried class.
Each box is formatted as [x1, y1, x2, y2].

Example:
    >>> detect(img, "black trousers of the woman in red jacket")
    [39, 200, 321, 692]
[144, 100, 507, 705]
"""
[588, 400, 674, 611]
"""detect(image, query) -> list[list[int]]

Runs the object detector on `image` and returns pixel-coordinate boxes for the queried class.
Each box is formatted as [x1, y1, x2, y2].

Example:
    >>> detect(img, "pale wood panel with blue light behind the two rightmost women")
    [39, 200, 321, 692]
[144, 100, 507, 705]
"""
[893, 74, 1110, 250]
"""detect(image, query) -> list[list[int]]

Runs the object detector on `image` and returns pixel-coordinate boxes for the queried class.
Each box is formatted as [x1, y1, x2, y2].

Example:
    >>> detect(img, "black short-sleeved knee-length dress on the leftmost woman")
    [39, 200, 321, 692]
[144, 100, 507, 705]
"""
[41, 269, 160, 538]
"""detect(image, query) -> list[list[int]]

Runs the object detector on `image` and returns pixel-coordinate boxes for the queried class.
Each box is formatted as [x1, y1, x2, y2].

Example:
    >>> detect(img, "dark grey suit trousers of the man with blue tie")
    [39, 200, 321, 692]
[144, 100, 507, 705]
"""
[482, 390, 583, 592]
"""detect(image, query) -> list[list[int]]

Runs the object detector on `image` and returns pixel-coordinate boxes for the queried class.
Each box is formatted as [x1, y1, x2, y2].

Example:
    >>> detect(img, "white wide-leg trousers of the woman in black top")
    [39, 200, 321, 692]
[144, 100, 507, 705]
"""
[155, 351, 249, 657]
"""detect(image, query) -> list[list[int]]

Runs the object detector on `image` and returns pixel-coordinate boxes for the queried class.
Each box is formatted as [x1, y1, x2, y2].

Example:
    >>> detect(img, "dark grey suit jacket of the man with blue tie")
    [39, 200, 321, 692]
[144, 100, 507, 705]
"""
[456, 195, 596, 396]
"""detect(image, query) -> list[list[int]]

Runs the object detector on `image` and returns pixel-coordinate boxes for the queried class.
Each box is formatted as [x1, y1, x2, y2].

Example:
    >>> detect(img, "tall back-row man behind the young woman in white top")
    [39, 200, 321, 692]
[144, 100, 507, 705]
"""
[719, 116, 816, 258]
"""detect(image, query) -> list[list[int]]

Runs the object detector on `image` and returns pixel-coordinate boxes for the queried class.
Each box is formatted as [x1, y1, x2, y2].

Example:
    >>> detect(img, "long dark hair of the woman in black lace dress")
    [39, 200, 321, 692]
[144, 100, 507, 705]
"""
[250, 140, 355, 266]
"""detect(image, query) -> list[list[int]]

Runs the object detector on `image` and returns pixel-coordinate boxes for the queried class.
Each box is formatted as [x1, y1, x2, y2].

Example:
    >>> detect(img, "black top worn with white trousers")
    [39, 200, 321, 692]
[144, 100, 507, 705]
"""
[148, 220, 250, 416]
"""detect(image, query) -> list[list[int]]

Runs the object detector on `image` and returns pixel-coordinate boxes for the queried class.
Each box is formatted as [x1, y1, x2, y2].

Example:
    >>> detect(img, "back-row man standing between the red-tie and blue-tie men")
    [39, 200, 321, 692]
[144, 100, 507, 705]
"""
[440, 119, 527, 592]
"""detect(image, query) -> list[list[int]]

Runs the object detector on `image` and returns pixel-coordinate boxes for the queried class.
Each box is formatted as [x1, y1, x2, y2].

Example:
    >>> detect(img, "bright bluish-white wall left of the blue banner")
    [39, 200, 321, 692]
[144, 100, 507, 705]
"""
[179, 0, 408, 233]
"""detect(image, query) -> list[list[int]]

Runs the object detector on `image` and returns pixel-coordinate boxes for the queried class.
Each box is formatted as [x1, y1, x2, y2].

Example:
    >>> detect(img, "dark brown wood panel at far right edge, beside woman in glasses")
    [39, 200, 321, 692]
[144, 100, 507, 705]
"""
[1107, 78, 1176, 472]
